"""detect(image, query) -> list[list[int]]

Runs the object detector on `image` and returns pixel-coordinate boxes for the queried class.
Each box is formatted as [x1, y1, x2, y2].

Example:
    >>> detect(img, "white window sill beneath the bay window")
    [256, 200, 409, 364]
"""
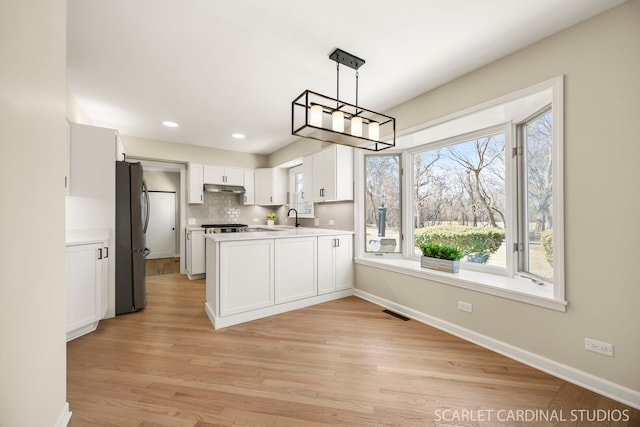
[354, 257, 567, 311]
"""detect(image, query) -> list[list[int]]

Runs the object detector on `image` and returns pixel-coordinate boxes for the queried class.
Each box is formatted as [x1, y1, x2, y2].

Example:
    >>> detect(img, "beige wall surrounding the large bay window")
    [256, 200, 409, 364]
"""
[356, 0, 640, 398]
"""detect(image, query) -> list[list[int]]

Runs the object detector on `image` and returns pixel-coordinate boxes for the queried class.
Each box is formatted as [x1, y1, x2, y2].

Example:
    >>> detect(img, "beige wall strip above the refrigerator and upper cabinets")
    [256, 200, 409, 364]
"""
[121, 135, 267, 168]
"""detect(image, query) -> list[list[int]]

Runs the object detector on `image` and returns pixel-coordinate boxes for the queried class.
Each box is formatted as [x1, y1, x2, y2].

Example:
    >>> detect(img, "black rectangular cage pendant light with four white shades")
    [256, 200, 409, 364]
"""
[291, 49, 396, 151]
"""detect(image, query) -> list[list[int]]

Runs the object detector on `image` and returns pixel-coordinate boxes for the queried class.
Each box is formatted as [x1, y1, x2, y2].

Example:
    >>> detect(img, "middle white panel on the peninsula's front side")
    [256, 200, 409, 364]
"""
[275, 237, 318, 304]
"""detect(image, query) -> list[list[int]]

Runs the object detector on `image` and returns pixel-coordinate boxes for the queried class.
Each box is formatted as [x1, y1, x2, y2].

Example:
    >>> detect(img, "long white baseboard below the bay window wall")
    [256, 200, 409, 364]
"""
[354, 289, 640, 409]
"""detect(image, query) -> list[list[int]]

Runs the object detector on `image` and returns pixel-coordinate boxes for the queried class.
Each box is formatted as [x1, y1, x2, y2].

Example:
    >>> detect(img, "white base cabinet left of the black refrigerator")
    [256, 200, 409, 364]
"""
[66, 241, 109, 341]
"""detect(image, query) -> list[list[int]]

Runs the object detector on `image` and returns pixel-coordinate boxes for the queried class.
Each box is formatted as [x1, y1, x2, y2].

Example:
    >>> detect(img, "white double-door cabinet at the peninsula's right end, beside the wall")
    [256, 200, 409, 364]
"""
[318, 234, 353, 295]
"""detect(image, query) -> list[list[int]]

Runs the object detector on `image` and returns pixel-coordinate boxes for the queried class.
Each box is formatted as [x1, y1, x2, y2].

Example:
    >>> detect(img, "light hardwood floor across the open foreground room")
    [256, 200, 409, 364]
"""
[67, 274, 640, 427]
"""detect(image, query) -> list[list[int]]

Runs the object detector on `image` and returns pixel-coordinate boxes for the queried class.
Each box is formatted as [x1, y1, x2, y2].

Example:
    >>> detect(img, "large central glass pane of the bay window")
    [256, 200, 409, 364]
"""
[413, 131, 507, 269]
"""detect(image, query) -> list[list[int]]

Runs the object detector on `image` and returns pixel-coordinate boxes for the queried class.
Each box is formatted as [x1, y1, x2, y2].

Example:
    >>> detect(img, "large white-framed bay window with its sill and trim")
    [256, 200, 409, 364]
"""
[356, 76, 567, 311]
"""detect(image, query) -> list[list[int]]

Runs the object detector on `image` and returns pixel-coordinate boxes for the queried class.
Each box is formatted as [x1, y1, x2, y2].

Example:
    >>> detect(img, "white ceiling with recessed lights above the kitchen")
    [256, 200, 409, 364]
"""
[67, 0, 623, 154]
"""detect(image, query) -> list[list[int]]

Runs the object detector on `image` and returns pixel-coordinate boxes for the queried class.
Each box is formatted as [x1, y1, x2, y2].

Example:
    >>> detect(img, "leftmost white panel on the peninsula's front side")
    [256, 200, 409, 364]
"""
[218, 239, 274, 316]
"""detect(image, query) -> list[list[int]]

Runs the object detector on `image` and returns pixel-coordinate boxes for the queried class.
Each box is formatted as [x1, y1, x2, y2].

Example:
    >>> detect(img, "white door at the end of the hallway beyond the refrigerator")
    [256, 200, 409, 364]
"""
[146, 191, 176, 259]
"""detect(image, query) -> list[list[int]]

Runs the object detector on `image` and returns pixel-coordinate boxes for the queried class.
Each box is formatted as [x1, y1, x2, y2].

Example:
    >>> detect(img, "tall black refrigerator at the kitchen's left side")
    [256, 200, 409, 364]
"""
[115, 162, 149, 315]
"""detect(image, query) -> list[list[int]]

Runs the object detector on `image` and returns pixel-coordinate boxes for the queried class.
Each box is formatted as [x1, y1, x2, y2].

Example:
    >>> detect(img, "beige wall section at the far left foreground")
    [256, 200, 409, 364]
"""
[0, 0, 67, 427]
